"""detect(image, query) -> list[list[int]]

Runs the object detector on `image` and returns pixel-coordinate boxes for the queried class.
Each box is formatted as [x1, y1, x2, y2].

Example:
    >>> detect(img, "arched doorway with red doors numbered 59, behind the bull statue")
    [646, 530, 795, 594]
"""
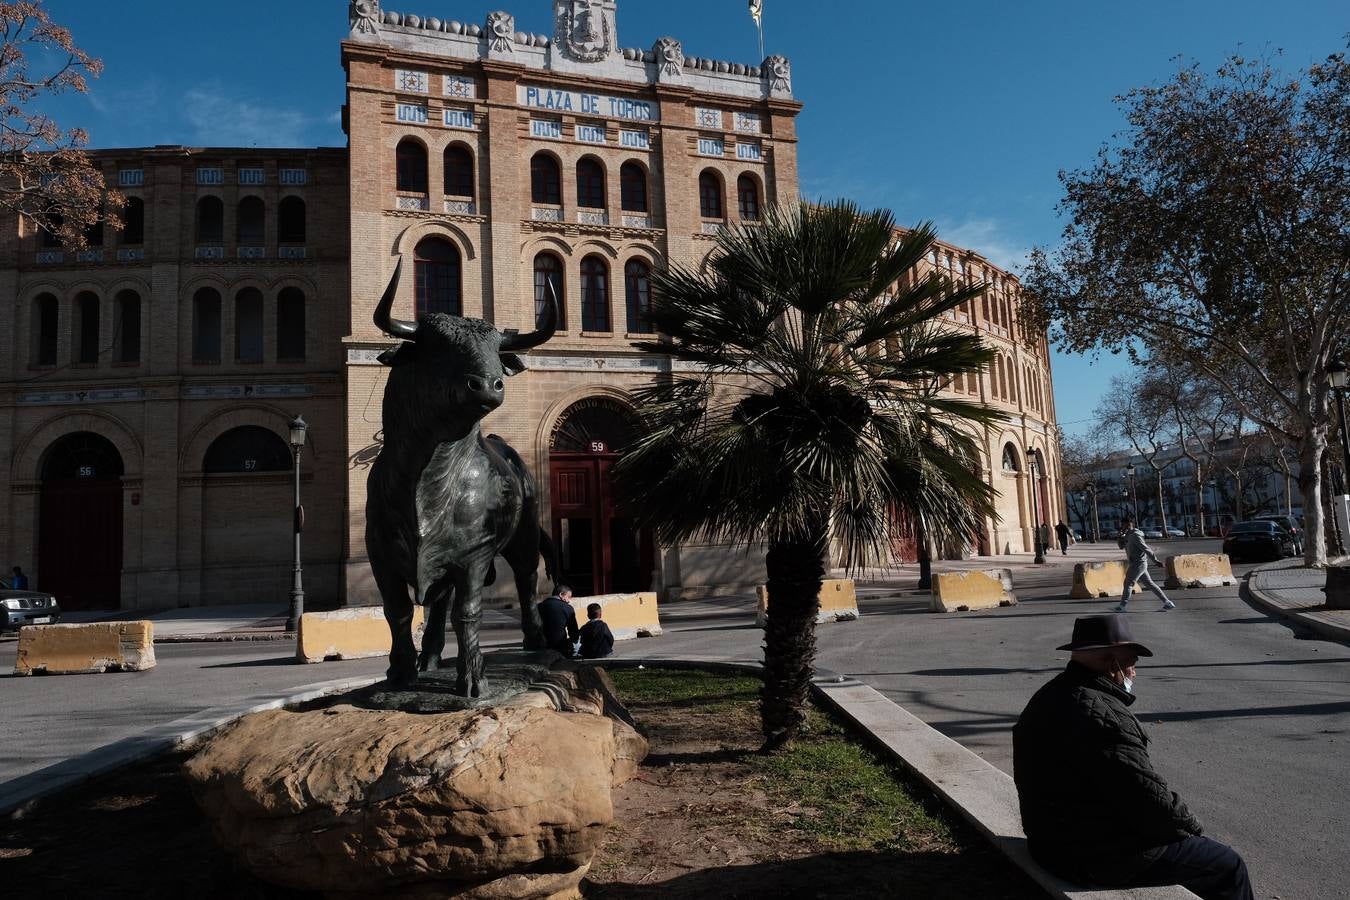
[548, 397, 656, 596]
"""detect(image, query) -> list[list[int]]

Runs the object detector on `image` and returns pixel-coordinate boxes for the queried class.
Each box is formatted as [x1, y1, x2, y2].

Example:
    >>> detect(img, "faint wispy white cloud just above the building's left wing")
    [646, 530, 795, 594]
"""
[182, 84, 328, 147]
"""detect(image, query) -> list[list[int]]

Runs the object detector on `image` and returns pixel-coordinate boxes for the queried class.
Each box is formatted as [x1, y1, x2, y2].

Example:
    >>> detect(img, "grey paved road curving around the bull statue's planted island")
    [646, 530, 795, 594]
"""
[0, 544, 1350, 900]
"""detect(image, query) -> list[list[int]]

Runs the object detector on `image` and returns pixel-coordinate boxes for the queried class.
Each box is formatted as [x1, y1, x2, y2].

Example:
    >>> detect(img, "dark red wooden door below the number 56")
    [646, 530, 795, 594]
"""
[38, 479, 122, 611]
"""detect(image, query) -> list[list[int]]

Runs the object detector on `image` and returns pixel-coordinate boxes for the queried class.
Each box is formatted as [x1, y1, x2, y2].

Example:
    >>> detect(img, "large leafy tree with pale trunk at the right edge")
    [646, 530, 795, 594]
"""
[1023, 53, 1350, 564]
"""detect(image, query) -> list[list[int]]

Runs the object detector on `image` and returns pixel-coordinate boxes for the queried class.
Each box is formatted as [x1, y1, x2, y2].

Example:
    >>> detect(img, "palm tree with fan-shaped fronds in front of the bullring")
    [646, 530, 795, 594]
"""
[616, 201, 998, 752]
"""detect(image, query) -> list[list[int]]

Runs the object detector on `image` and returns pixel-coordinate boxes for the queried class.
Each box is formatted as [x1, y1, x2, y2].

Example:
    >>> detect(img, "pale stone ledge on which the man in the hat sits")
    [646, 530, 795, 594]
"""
[811, 679, 1197, 900]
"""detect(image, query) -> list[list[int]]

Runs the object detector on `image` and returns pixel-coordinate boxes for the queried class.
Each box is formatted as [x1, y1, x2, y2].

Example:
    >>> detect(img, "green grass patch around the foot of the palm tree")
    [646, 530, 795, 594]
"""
[610, 669, 960, 851]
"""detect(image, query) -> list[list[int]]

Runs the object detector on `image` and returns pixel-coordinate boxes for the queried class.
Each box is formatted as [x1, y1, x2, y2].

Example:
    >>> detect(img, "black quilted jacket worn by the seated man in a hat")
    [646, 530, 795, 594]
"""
[1013, 663, 1200, 884]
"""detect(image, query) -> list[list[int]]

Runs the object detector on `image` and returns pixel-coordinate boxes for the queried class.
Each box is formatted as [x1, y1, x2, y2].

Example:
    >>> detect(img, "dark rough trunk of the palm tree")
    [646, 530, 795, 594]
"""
[760, 536, 825, 753]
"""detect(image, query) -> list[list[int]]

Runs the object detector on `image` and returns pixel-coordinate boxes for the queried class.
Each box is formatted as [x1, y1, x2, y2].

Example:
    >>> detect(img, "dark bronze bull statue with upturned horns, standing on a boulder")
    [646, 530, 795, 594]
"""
[366, 259, 558, 698]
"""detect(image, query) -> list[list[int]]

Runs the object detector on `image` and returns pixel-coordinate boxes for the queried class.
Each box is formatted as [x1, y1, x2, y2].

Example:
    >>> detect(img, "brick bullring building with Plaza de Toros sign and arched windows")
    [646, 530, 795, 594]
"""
[0, 0, 1061, 610]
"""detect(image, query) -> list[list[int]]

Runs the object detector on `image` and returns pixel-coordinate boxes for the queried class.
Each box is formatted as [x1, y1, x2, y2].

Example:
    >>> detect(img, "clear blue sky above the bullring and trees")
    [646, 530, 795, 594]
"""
[36, 0, 1350, 433]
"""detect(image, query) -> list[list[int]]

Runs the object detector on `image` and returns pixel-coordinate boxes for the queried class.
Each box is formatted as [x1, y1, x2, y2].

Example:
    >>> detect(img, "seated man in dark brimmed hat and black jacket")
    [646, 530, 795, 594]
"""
[1013, 615, 1253, 900]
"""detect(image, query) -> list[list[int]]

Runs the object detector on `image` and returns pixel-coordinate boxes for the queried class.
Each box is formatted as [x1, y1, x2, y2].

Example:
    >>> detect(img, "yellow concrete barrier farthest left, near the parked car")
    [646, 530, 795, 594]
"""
[14, 621, 155, 675]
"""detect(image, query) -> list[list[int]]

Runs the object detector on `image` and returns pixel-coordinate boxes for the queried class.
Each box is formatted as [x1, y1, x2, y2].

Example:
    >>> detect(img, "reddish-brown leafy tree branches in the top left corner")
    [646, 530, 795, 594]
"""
[0, 1, 123, 250]
